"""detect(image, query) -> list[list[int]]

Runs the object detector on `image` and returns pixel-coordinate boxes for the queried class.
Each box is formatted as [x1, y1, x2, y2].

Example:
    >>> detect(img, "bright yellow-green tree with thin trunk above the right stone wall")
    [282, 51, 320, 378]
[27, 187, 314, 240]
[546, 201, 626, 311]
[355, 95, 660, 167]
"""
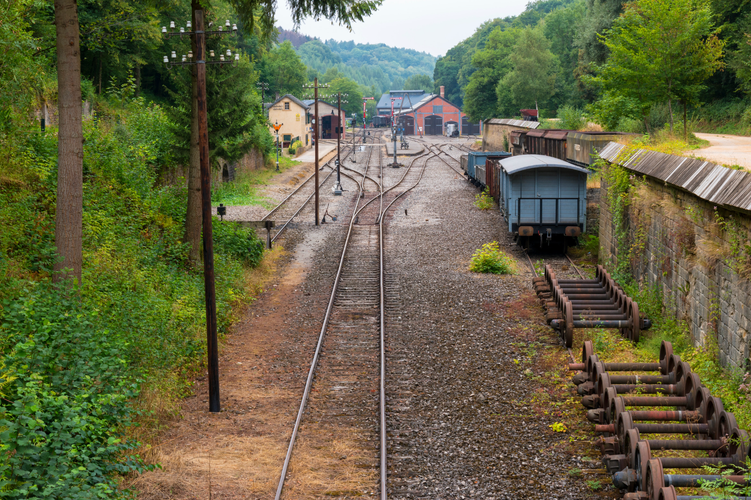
[595, 0, 724, 132]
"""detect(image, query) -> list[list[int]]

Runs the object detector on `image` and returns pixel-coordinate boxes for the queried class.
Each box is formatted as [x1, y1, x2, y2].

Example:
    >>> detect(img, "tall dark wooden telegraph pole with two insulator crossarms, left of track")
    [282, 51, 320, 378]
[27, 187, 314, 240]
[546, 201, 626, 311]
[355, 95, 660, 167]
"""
[162, 9, 240, 413]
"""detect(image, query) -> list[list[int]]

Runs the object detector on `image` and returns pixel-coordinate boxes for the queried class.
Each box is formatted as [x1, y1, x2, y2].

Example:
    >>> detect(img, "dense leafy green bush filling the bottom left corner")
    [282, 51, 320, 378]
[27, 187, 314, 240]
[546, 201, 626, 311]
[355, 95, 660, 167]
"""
[0, 282, 153, 499]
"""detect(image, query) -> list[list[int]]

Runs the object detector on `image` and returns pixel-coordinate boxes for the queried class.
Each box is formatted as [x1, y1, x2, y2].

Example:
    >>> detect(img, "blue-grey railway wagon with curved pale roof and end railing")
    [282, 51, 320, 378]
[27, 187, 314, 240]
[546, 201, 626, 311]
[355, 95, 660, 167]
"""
[498, 155, 589, 242]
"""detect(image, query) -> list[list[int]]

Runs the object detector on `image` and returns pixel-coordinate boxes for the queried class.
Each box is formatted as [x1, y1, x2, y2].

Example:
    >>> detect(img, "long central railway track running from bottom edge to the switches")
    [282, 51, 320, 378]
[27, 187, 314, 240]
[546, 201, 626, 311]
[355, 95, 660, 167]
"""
[275, 135, 435, 499]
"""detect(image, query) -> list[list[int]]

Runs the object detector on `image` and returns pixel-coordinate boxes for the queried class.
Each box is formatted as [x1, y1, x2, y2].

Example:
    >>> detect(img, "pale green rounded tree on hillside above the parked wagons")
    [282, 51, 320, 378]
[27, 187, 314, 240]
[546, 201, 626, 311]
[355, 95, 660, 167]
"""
[502, 27, 558, 109]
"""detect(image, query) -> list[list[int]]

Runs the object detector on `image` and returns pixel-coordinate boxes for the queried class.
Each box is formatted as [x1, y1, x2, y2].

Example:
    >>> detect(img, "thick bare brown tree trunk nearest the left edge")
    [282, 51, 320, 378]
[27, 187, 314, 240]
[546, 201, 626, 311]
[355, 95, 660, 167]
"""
[55, 0, 83, 283]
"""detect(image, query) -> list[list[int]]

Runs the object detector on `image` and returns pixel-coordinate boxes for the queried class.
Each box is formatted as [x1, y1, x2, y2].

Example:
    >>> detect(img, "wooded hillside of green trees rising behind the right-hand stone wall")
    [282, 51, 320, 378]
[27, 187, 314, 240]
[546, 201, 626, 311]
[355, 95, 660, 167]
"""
[433, 0, 751, 131]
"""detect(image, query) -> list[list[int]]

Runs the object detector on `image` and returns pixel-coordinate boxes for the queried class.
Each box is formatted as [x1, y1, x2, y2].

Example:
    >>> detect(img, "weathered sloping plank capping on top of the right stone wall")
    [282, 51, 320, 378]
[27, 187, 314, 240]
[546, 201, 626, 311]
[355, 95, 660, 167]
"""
[600, 142, 751, 211]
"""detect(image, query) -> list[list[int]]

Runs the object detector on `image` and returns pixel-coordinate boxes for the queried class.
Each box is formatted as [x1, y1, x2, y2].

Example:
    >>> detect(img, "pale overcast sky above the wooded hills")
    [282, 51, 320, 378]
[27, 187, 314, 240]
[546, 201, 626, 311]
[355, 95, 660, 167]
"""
[276, 0, 529, 56]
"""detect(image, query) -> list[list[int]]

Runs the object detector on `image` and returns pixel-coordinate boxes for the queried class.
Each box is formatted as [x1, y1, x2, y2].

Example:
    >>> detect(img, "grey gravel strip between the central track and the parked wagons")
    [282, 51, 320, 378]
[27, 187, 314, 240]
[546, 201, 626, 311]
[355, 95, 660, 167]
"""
[386, 137, 595, 499]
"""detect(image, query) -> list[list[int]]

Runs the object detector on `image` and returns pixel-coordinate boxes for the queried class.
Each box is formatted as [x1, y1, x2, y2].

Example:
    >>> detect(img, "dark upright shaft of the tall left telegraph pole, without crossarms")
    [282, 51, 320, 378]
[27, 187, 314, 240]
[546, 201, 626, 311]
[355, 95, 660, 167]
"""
[195, 9, 221, 413]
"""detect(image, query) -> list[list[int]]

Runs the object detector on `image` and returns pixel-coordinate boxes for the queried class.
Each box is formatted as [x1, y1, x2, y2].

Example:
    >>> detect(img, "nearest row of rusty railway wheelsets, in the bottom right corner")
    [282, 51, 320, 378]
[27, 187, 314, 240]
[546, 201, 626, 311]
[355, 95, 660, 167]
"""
[569, 341, 751, 500]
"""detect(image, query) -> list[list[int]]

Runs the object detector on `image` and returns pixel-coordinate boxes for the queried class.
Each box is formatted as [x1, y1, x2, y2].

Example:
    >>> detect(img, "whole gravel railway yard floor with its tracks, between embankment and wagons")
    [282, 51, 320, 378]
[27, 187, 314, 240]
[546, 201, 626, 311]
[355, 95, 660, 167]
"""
[136, 131, 748, 500]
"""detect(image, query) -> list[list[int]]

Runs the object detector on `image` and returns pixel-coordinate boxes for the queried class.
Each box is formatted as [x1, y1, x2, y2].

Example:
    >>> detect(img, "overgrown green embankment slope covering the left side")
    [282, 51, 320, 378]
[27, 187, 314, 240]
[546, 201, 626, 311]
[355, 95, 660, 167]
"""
[0, 92, 263, 499]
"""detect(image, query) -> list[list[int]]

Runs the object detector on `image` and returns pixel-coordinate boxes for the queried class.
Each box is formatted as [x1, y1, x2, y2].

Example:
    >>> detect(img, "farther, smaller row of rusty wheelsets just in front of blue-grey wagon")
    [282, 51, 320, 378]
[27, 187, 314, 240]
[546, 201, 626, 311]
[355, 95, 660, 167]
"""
[532, 264, 652, 347]
